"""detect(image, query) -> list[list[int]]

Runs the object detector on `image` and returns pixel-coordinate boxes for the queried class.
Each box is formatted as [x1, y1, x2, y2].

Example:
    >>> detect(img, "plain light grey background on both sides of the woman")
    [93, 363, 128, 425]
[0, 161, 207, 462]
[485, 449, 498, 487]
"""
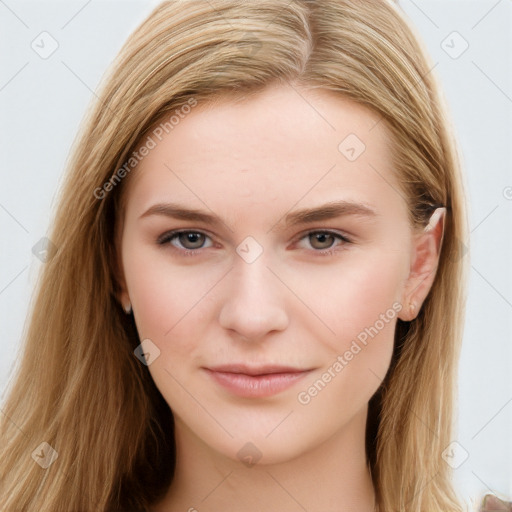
[0, 0, 512, 507]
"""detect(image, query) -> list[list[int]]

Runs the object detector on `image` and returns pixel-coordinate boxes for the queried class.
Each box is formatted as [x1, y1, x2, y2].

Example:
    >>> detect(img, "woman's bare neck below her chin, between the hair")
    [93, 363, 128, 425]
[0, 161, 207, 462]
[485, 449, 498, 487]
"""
[152, 408, 375, 512]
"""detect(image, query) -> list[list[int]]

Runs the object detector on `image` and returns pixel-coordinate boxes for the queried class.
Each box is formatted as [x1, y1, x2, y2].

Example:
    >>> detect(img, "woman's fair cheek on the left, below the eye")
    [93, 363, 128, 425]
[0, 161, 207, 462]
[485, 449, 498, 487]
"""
[125, 250, 225, 404]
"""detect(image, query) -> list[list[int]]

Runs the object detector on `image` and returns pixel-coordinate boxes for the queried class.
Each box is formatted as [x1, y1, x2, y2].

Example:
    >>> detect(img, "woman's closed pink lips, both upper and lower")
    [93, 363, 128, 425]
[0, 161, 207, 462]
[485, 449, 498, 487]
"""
[204, 364, 310, 398]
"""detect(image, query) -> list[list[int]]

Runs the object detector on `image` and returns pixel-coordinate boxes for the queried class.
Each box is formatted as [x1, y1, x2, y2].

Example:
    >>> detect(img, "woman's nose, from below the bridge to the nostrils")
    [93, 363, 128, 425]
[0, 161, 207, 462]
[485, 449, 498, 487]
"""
[219, 257, 289, 341]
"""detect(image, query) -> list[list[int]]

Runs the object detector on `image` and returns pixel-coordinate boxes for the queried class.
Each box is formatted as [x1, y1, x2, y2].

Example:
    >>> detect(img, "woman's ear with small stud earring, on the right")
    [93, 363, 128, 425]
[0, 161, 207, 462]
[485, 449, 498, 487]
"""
[398, 207, 446, 322]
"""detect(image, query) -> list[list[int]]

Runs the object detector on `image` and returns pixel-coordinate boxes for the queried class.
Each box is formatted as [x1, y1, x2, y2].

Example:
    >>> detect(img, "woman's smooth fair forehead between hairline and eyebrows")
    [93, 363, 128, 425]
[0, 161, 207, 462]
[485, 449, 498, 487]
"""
[123, 85, 403, 222]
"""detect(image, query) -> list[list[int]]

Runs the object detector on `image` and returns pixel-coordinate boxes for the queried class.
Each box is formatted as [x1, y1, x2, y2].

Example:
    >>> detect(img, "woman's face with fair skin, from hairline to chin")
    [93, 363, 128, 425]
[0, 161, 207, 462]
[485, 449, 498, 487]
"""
[121, 86, 415, 463]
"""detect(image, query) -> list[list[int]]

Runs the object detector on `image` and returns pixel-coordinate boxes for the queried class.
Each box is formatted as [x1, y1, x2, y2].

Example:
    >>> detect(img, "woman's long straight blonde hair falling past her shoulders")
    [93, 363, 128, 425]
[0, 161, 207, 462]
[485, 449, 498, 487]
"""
[0, 0, 467, 512]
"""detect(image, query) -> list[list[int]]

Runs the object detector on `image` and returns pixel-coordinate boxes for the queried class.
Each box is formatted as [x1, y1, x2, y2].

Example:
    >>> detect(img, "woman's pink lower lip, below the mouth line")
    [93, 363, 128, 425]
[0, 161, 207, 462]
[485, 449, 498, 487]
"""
[206, 369, 309, 398]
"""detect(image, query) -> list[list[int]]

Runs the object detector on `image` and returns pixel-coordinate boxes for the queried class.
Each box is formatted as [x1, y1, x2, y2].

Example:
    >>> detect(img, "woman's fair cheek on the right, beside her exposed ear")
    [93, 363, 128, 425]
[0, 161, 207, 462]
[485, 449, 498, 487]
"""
[294, 251, 403, 396]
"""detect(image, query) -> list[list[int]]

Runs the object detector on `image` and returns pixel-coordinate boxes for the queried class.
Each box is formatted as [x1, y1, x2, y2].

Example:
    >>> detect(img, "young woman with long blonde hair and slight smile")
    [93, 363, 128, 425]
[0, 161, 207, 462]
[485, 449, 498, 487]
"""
[0, 0, 467, 512]
